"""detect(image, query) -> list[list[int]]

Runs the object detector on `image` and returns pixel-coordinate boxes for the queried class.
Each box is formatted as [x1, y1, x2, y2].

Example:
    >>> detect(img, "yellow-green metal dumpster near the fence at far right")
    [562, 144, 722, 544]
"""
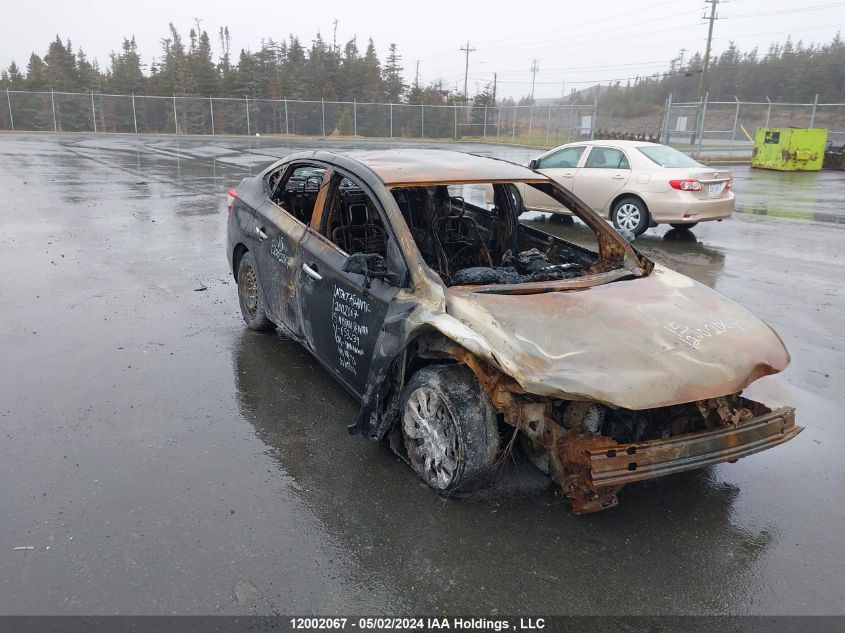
[751, 127, 827, 171]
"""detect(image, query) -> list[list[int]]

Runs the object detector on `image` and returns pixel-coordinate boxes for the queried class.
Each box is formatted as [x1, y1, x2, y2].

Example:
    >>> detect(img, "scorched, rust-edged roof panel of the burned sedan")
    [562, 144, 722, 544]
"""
[332, 149, 549, 187]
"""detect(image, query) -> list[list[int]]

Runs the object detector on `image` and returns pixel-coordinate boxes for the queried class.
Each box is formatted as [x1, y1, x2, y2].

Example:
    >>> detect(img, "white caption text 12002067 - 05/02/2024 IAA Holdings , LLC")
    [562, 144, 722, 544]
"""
[290, 617, 546, 633]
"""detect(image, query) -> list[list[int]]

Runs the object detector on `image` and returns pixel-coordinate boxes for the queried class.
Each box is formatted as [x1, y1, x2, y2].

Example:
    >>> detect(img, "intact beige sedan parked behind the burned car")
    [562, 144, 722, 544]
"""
[520, 141, 734, 235]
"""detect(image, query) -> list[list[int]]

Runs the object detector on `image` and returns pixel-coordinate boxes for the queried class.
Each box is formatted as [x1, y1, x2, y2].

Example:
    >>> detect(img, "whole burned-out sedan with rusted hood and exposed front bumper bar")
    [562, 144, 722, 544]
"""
[227, 150, 802, 513]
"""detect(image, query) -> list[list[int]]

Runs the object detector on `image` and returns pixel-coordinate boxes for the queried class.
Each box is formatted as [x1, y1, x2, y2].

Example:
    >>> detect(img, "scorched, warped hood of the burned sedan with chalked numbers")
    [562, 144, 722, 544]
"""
[446, 266, 789, 409]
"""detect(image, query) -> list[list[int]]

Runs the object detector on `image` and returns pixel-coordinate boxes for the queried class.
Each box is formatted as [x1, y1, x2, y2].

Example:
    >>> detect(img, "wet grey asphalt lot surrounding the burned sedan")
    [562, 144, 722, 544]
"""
[0, 134, 845, 615]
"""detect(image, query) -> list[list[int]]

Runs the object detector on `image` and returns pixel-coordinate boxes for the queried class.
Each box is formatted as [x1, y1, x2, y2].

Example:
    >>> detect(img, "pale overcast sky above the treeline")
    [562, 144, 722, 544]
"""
[0, 0, 845, 98]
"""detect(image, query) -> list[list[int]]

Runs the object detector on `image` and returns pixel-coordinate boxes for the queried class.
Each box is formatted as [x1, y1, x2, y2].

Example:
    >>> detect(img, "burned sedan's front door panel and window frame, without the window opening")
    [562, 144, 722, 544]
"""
[297, 165, 410, 400]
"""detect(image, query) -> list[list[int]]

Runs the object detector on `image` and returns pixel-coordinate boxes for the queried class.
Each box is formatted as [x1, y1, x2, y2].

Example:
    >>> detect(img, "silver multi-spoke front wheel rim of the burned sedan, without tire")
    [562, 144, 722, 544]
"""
[402, 387, 458, 490]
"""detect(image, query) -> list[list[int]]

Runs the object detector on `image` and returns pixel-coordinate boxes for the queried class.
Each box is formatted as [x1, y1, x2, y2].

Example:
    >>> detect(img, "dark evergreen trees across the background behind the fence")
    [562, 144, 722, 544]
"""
[0, 23, 845, 139]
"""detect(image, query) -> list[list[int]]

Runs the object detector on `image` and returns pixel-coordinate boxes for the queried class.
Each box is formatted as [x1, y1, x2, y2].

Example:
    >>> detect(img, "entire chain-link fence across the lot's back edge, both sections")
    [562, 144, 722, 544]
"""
[6, 90, 845, 156]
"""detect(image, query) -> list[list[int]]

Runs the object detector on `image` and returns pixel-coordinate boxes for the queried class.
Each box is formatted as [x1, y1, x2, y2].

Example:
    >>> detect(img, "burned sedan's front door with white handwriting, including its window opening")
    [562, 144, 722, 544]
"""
[298, 165, 407, 397]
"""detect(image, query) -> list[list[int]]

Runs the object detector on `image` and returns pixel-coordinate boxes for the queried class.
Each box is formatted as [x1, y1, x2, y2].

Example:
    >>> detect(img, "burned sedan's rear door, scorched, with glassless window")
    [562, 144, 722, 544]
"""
[254, 163, 325, 335]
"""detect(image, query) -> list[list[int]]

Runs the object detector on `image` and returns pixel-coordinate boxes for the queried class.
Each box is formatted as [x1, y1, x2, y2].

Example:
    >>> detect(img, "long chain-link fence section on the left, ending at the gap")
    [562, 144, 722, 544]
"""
[0, 90, 596, 146]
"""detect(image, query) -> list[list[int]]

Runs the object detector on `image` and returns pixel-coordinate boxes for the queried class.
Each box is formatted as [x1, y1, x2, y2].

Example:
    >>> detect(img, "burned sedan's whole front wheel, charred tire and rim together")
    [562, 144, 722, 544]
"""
[400, 365, 499, 496]
